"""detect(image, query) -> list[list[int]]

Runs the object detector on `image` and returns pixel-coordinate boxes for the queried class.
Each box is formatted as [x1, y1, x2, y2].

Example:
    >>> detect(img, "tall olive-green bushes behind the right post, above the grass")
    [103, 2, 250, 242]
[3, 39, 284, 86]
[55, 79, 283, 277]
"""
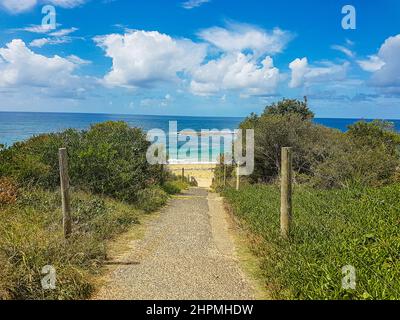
[236, 100, 400, 188]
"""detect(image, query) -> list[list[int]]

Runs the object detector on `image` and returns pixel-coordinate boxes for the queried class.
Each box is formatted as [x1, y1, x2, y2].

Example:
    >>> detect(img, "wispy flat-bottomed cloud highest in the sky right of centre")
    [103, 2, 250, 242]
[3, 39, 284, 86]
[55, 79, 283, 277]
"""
[199, 23, 293, 55]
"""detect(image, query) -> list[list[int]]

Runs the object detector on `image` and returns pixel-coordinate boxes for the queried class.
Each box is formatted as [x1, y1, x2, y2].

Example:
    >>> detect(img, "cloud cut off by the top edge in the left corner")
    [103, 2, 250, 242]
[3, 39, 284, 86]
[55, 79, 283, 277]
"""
[0, 0, 88, 14]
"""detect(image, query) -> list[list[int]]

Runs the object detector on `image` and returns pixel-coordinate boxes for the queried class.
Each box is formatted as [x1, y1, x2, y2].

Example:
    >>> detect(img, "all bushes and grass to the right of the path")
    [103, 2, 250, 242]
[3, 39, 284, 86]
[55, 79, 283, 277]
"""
[214, 100, 400, 299]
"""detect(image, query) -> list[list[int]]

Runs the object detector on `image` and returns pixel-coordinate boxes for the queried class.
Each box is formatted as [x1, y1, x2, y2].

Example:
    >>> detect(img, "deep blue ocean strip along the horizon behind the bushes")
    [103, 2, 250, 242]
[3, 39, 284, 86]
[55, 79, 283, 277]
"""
[0, 112, 400, 160]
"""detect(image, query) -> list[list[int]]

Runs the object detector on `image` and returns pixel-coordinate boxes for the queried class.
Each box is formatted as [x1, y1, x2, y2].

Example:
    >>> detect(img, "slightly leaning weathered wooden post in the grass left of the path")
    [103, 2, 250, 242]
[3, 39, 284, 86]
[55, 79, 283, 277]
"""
[58, 148, 72, 239]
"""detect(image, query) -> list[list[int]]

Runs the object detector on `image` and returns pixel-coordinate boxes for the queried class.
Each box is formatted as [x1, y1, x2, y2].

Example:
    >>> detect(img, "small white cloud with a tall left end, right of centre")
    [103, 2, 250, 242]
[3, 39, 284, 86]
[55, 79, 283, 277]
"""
[289, 58, 349, 88]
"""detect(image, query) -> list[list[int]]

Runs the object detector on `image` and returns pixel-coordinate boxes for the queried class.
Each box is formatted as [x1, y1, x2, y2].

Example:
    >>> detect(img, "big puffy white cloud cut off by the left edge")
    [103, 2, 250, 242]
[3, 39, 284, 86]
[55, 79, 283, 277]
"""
[0, 39, 88, 93]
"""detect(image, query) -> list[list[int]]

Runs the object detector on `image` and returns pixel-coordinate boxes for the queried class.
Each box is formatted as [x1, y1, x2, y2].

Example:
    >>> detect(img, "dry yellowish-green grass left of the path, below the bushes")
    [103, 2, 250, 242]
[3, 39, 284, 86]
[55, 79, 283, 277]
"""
[0, 184, 184, 300]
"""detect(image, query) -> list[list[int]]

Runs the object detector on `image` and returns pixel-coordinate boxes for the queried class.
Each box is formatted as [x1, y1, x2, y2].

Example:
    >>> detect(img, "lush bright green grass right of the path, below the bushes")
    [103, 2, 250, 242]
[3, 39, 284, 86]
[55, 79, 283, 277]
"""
[224, 185, 400, 299]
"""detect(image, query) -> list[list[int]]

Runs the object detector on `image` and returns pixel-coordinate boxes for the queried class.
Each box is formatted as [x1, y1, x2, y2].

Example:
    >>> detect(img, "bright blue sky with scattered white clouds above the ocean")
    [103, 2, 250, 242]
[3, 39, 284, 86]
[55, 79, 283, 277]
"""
[0, 0, 400, 119]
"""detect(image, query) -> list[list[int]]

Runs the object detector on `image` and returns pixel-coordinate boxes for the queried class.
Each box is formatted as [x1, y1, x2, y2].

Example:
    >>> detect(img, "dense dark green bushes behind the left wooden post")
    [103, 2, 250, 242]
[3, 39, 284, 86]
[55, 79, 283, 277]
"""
[0, 122, 161, 202]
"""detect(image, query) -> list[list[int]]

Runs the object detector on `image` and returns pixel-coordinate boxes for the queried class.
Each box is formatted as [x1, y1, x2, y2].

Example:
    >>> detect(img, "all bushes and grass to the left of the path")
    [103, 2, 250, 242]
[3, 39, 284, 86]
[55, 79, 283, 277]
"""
[0, 122, 187, 300]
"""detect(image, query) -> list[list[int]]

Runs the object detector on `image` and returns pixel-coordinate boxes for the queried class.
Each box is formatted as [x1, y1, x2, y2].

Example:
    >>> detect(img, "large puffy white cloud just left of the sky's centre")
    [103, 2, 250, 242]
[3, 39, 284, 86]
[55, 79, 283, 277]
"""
[95, 31, 206, 87]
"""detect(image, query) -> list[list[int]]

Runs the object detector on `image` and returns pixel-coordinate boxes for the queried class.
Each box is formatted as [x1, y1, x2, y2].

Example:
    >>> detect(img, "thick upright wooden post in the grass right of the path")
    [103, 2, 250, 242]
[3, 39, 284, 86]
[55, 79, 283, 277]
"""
[281, 148, 292, 238]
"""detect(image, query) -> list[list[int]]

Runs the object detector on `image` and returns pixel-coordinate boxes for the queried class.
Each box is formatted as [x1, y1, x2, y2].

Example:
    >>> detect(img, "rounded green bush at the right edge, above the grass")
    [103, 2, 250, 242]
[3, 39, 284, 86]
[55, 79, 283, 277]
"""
[311, 121, 400, 187]
